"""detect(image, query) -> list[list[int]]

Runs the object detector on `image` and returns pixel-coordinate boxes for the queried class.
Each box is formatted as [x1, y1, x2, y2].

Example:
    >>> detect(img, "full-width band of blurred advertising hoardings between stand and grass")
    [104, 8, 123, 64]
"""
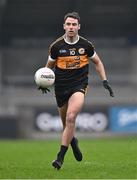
[0, 106, 137, 138]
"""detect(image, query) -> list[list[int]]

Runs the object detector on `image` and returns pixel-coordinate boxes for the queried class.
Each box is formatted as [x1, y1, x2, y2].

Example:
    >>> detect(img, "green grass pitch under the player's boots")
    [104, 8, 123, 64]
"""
[0, 136, 137, 179]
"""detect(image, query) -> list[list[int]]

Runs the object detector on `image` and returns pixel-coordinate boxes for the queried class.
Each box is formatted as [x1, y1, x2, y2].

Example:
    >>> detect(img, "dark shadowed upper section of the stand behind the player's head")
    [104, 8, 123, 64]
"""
[2, 0, 137, 40]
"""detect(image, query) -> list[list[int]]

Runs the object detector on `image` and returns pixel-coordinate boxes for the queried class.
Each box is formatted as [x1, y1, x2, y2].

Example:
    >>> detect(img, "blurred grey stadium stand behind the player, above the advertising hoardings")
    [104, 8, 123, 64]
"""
[0, 0, 137, 139]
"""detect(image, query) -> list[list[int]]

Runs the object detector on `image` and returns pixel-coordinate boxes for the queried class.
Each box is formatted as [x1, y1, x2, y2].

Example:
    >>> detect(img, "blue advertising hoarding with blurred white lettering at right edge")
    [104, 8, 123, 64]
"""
[109, 106, 137, 133]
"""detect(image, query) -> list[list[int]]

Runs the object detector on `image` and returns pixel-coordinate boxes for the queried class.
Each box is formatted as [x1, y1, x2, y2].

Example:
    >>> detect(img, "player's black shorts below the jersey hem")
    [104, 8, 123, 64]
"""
[55, 84, 87, 107]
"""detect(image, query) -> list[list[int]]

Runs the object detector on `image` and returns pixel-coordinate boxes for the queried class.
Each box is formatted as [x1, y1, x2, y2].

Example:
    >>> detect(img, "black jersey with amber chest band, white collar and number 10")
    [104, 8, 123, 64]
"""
[49, 36, 95, 89]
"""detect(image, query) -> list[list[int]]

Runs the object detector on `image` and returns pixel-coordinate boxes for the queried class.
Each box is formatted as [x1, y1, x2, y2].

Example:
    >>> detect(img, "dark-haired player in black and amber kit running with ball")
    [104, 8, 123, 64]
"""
[39, 12, 114, 169]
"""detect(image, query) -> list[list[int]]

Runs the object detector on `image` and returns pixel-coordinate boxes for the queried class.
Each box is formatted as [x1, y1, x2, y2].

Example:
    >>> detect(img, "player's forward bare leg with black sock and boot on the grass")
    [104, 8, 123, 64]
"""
[52, 92, 84, 169]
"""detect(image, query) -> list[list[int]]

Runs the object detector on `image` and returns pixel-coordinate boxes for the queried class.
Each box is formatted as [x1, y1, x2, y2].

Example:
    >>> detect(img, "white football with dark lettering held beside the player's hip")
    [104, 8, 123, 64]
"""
[34, 67, 55, 88]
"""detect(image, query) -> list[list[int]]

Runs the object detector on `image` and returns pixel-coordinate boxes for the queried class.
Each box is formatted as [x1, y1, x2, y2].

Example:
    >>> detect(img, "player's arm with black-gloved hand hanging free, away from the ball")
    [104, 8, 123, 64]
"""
[91, 53, 114, 97]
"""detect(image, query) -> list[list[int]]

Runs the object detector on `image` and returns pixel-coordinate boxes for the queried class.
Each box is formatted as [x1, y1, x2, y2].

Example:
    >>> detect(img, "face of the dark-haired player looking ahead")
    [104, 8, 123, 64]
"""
[64, 17, 80, 37]
